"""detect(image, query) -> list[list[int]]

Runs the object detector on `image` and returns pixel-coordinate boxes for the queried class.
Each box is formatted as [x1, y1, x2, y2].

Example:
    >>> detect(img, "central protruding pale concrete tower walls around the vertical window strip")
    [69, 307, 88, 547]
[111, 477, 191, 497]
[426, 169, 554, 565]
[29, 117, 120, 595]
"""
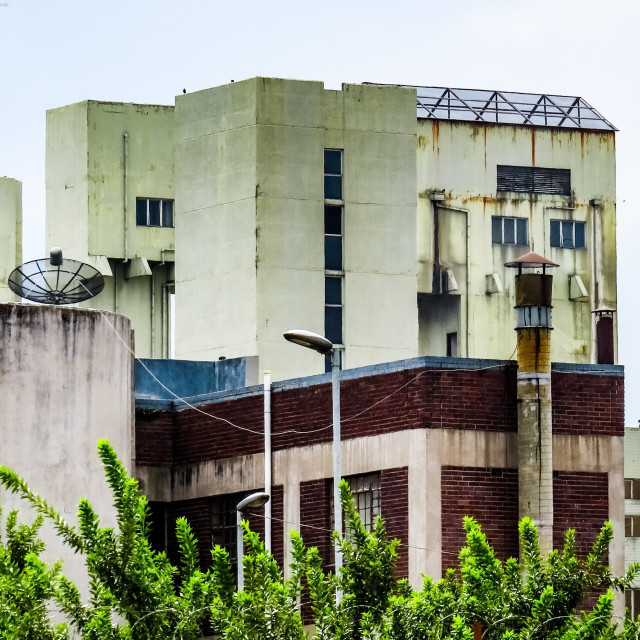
[176, 78, 417, 380]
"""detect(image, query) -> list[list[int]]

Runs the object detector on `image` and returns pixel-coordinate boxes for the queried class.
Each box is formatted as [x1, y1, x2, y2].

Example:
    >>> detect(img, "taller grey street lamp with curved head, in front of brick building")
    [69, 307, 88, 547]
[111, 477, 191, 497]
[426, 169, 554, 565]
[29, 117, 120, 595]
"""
[284, 329, 342, 603]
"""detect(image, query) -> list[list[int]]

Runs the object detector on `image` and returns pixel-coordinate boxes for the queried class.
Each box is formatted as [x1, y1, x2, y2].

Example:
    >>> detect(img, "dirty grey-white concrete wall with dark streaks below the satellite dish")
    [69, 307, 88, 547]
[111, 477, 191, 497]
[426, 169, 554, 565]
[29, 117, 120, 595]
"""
[0, 304, 133, 588]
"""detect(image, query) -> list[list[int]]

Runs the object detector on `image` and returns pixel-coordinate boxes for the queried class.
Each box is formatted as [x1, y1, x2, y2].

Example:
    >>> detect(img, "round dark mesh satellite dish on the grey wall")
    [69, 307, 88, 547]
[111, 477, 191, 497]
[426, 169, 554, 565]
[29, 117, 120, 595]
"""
[9, 247, 104, 305]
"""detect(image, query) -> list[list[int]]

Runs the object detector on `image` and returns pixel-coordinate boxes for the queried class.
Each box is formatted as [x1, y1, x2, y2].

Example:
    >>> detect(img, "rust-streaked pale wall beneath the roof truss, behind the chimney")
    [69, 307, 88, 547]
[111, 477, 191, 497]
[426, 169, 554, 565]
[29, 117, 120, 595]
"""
[417, 120, 617, 363]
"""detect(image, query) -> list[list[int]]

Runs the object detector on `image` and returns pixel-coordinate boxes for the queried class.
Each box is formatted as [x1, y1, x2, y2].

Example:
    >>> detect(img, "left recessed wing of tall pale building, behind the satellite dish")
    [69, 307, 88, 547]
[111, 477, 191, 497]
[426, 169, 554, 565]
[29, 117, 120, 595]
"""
[46, 100, 174, 358]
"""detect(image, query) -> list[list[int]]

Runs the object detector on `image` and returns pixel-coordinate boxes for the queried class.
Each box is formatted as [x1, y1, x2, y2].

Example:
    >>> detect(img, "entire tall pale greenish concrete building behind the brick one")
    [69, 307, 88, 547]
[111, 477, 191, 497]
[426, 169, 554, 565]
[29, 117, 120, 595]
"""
[47, 78, 617, 379]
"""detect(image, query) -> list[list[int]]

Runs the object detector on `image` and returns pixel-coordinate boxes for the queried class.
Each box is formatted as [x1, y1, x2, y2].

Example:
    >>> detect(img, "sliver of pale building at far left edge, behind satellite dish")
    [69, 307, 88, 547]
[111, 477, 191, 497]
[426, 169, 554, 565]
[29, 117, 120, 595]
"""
[0, 178, 22, 302]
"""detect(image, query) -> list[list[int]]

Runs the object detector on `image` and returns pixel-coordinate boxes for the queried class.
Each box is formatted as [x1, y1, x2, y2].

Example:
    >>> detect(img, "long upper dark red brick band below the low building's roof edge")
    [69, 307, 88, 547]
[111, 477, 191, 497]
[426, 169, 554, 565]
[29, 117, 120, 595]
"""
[136, 366, 624, 466]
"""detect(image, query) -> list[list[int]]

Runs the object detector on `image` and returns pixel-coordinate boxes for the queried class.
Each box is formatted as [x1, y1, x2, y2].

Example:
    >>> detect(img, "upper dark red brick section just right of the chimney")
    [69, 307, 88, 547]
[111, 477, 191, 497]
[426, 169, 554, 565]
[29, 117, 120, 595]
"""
[551, 372, 624, 436]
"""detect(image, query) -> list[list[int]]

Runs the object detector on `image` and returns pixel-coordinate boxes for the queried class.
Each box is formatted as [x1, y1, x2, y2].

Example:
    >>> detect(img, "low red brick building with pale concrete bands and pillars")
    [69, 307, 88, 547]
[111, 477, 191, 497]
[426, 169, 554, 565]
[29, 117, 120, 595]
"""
[136, 346, 624, 587]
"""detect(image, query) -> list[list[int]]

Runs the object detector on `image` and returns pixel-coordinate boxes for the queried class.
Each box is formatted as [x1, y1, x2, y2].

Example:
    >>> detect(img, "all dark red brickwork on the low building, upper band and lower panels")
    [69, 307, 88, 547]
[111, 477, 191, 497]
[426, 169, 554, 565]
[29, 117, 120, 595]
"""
[136, 361, 624, 577]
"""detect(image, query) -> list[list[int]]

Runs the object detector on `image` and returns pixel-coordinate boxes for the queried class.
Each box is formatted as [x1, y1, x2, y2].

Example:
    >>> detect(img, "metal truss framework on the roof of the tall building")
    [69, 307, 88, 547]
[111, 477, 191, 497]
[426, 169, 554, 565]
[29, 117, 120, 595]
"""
[396, 85, 617, 131]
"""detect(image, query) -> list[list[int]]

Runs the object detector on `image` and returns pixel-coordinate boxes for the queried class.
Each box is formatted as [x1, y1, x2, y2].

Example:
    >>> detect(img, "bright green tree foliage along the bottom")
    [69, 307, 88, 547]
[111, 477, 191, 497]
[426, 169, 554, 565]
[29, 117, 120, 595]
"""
[0, 440, 640, 640]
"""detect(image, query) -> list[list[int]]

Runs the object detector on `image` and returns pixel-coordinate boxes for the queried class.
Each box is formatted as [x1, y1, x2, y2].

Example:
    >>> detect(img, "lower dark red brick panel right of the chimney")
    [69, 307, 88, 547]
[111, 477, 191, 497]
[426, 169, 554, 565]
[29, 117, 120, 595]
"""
[553, 471, 609, 554]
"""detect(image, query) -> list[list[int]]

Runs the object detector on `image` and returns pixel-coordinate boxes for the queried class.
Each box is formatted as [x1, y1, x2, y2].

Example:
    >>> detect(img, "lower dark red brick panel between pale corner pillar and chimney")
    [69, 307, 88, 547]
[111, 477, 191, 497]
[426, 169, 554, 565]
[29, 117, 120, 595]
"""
[441, 466, 518, 572]
